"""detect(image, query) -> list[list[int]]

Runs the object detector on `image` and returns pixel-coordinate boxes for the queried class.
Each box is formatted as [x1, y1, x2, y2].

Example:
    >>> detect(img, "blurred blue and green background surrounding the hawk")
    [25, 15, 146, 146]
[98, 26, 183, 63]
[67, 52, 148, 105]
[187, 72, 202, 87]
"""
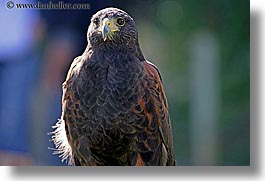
[0, 0, 250, 165]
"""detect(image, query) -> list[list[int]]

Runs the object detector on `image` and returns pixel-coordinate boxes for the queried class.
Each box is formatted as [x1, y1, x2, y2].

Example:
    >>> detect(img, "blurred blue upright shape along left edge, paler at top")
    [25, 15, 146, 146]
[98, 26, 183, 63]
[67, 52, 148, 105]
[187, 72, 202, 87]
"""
[0, 1, 40, 165]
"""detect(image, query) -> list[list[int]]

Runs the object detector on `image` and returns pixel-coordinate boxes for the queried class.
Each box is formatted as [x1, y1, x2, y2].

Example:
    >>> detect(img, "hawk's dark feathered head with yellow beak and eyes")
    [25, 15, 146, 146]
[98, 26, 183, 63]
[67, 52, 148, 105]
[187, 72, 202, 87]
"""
[87, 8, 138, 47]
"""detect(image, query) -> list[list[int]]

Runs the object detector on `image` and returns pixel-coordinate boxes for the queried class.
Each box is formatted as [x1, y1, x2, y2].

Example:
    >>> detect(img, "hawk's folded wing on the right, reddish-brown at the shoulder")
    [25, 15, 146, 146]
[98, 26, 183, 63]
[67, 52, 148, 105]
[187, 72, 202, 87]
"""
[132, 61, 175, 165]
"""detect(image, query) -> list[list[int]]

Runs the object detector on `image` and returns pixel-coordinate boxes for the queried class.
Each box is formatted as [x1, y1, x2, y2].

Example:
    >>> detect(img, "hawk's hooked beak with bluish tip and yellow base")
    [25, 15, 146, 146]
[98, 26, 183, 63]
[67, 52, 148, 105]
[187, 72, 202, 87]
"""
[100, 18, 119, 41]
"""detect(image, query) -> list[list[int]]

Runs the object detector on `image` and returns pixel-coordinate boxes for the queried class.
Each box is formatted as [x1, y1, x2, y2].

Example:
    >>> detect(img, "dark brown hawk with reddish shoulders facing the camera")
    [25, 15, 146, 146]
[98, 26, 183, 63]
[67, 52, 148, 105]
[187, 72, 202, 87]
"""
[52, 8, 175, 166]
